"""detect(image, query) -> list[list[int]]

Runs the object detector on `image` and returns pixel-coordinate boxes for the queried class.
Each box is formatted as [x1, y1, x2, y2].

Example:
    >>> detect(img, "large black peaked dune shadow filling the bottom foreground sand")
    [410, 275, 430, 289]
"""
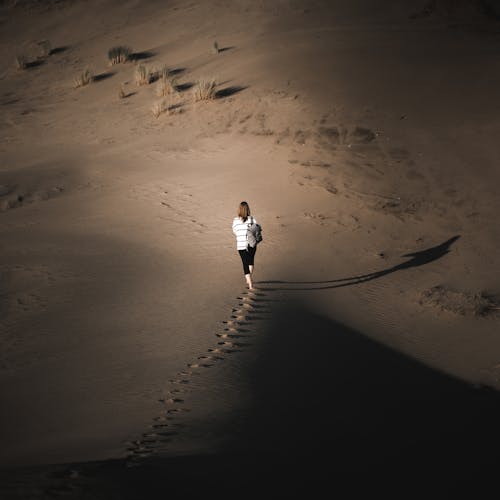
[1, 303, 500, 499]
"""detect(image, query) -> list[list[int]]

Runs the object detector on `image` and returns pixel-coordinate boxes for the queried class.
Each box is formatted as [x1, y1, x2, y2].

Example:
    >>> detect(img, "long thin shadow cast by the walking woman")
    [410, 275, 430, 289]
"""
[257, 235, 460, 291]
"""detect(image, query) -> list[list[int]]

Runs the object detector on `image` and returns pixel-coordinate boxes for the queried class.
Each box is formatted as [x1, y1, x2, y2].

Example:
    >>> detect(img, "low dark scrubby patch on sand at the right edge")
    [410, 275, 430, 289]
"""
[420, 285, 500, 317]
